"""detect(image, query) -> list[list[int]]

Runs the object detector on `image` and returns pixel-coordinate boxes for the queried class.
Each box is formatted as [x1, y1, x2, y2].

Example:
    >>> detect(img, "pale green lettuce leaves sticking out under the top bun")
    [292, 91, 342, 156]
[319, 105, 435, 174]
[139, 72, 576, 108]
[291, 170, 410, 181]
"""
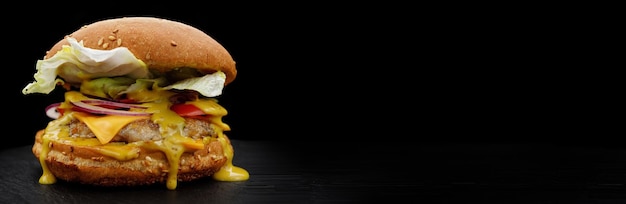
[22, 38, 226, 98]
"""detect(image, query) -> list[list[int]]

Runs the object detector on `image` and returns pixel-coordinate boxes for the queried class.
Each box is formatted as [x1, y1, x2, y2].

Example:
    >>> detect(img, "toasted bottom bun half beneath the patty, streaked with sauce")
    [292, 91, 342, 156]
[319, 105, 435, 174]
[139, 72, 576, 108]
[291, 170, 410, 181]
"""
[32, 130, 227, 186]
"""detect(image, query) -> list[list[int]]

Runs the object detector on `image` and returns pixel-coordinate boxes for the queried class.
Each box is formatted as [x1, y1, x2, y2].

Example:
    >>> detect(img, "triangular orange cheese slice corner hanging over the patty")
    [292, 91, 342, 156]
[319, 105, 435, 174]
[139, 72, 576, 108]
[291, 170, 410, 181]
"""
[74, 112, 150, 144]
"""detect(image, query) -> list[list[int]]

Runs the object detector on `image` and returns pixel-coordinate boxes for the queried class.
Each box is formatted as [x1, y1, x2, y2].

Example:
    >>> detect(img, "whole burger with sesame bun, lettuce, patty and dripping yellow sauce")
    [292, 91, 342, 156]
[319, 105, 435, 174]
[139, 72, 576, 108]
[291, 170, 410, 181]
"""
[22, 16, 249, 190]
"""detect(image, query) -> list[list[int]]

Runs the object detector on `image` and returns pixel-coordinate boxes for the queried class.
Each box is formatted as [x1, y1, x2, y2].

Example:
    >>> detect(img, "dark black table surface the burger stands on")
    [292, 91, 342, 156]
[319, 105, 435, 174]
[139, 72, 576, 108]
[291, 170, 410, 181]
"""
[0, 140, 626, 203]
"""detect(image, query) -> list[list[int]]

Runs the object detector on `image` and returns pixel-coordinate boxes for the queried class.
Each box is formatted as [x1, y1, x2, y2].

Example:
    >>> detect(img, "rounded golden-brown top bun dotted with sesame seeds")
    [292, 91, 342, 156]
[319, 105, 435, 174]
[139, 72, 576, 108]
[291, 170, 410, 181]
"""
[46, 17, 237, 84]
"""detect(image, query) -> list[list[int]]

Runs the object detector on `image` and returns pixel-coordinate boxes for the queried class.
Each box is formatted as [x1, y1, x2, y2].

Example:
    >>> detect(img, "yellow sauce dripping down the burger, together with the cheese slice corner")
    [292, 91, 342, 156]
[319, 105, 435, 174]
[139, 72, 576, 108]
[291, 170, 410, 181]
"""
[39, 91, 249, 190]
